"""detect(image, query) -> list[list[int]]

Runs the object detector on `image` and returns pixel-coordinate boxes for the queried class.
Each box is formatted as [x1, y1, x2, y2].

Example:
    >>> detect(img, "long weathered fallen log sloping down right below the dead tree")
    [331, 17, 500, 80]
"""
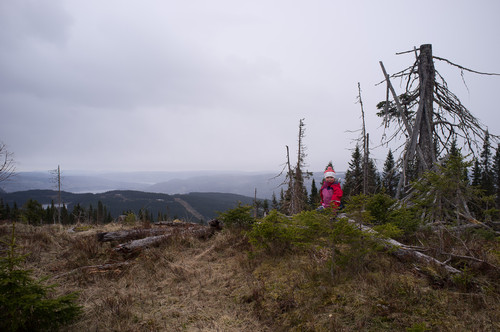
[339, 214, 462, 273]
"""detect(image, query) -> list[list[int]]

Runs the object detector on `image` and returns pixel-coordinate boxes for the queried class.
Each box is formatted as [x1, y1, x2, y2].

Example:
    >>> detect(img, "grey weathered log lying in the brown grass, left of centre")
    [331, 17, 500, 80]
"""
[113, 226, 215, 253]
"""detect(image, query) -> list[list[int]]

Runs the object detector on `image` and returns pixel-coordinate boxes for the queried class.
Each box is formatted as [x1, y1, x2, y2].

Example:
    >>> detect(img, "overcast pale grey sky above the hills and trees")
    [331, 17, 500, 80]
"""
[0, 0, 500, 172]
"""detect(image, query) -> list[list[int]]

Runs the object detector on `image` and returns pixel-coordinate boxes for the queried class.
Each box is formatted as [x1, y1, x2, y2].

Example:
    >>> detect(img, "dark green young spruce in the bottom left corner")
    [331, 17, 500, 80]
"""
[0, 225, 82, 331]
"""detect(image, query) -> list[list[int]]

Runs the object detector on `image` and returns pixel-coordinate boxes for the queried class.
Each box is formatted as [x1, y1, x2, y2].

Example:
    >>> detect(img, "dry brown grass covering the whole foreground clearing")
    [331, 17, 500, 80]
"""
[0, 223, 500, 331]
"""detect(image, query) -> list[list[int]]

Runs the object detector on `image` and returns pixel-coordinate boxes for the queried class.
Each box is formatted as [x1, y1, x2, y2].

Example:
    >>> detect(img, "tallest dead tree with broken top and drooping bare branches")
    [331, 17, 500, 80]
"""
[377, 44, 499, 198]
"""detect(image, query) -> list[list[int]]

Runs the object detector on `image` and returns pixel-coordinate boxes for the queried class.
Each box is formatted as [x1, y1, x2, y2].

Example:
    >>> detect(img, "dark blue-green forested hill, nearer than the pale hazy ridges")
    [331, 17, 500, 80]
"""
[0, 190, 253, 221]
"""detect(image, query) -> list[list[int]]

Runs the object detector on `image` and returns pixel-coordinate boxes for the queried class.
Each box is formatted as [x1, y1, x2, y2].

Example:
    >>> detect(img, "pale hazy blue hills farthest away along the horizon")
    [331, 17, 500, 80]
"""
[0, 171, 344, 199]
